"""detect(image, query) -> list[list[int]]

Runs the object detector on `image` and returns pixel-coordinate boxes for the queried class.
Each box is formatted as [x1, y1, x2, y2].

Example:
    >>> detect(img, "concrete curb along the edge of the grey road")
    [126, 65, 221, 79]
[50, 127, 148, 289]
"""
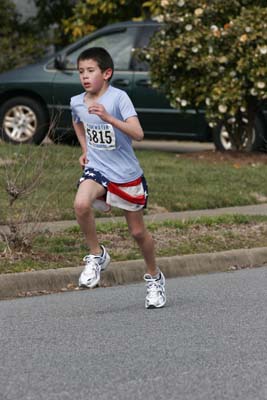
[0, 247, 267, 300]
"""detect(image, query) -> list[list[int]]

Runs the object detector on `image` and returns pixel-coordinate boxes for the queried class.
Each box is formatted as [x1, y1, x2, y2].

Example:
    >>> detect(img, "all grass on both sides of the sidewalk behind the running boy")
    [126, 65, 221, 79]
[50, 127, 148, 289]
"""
[0, 142, 267, 273]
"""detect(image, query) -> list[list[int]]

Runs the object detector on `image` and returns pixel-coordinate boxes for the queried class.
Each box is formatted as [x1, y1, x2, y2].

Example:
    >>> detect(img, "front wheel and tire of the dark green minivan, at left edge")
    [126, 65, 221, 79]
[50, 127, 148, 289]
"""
[0, 96, 48, 144]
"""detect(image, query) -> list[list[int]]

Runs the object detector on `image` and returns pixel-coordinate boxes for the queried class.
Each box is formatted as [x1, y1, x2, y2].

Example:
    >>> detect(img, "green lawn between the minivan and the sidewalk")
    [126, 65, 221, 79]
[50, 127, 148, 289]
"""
[0, 143, 267, 223]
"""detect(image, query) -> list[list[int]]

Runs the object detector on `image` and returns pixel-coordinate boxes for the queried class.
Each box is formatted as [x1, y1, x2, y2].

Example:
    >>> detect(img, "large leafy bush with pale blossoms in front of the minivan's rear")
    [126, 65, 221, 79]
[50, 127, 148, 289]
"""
[145, 0, 267, 150]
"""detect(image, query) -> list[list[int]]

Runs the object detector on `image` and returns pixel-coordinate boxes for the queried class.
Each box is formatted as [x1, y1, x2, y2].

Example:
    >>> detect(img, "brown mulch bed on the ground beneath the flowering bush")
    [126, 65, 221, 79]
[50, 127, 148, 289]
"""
[176, 150, 267, 167]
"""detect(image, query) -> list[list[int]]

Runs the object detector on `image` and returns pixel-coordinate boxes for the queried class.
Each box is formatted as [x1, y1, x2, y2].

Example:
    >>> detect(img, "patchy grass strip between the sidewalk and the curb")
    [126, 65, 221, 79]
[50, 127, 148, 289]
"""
[0, 215, 267, 273]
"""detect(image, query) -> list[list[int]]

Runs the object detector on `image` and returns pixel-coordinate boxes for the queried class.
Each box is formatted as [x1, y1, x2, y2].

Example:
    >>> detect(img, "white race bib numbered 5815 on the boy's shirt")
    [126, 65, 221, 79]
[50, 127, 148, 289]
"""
[84, 124, 116, 150]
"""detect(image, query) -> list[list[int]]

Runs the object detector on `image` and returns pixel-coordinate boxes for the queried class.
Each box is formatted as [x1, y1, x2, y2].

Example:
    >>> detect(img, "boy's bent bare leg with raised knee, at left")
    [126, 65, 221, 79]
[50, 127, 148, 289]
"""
[74, 179, 105, 254]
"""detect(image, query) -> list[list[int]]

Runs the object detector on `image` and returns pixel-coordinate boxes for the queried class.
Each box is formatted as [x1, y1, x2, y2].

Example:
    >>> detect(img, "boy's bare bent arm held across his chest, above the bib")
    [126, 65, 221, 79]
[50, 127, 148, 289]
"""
[88, 103, 144, 141]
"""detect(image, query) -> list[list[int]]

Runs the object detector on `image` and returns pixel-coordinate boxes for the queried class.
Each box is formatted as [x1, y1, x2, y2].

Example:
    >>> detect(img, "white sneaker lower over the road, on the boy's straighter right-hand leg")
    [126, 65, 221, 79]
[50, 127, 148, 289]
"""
[144, 272, 166, 308]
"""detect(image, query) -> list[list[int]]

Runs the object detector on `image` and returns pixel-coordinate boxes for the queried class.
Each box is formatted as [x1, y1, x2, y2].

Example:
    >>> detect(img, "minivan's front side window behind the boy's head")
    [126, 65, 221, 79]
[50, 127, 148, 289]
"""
[63, 28, 137, 71]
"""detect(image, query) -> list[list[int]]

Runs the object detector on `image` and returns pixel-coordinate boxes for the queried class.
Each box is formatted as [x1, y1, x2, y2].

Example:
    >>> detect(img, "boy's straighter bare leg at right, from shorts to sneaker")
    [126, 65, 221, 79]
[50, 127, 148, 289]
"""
[125, 210, 158, 276]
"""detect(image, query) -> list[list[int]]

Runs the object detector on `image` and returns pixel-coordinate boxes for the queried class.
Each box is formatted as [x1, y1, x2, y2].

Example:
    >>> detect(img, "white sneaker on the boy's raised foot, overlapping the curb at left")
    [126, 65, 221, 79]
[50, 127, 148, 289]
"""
[79, 246, 110, 288]
